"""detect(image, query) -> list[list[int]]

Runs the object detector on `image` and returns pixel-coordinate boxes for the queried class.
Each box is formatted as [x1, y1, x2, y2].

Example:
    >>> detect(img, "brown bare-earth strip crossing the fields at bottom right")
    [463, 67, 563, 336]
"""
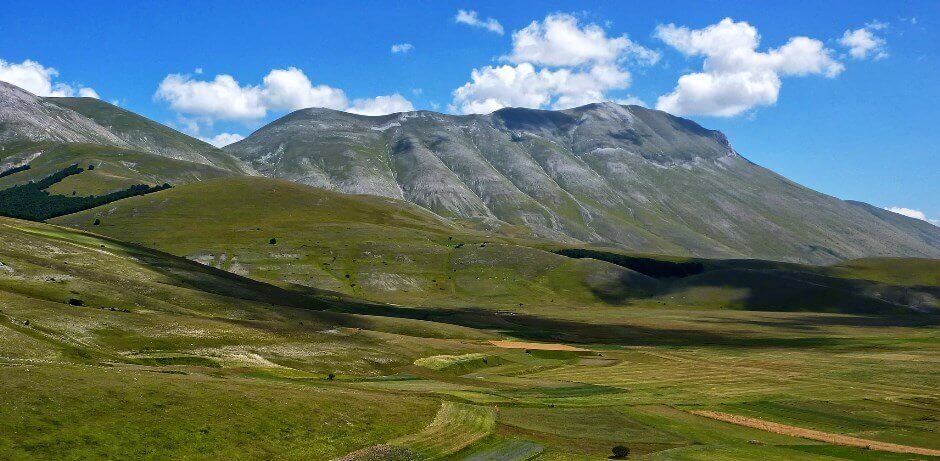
[690, 410, 940, 456]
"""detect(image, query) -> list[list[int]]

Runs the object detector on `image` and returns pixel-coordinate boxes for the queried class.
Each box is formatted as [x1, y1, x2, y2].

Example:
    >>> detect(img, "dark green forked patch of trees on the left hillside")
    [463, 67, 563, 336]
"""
[0, 165, 171, 221]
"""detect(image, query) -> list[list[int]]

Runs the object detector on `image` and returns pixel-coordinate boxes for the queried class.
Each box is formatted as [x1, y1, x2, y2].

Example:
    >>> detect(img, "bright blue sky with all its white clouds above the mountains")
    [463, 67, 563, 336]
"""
[0, 0, 940, 223]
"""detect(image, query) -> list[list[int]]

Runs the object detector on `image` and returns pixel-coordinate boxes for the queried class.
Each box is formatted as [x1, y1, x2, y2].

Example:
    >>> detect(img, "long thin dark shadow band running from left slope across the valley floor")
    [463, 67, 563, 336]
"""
[60, 230, 940, 348]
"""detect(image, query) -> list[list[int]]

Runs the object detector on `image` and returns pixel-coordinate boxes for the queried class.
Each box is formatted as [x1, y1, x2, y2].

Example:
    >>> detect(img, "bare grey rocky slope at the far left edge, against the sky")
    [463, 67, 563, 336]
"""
[0, 82, 131, 147]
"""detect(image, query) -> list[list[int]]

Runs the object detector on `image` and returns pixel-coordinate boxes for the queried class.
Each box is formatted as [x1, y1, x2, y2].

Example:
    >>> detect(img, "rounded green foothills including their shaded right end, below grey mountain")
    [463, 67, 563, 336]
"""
[53, 177, 940, 313]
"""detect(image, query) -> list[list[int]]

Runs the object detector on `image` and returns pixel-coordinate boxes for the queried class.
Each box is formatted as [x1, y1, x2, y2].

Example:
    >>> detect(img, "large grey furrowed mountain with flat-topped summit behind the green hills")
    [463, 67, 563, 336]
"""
[225, 103, 940, 263]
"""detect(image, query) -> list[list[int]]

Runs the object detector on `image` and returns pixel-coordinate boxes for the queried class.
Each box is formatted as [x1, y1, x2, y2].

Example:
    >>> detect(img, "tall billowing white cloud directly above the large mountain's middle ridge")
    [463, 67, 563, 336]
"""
[450, 13, 659, 113]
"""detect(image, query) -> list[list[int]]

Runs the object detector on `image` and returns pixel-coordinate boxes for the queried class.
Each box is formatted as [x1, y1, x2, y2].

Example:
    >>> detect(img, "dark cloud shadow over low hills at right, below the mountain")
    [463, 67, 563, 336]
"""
[555, 248, 940, 315]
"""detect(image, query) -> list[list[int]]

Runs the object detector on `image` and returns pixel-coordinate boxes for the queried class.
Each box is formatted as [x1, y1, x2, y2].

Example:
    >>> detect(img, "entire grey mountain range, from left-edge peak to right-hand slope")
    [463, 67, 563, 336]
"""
[0, 78, 940, 263]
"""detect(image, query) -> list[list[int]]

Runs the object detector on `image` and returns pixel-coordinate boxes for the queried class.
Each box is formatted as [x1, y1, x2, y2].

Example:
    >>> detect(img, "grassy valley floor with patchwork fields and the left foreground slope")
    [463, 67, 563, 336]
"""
[0, 219, 940, 461]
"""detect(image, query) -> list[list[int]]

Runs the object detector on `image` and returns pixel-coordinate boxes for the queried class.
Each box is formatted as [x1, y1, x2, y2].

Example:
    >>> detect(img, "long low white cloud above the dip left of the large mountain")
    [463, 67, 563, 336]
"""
[154, 67, 411, 123]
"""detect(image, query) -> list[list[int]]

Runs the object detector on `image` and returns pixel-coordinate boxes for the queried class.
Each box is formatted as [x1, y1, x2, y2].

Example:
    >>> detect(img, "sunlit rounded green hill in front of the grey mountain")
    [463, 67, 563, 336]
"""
[55, 177, 645, 307]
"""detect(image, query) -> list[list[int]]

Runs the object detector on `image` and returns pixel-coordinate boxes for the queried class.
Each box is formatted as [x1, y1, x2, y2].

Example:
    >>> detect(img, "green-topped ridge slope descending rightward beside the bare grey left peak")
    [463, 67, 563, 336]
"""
[51, 98, 248, 171]
